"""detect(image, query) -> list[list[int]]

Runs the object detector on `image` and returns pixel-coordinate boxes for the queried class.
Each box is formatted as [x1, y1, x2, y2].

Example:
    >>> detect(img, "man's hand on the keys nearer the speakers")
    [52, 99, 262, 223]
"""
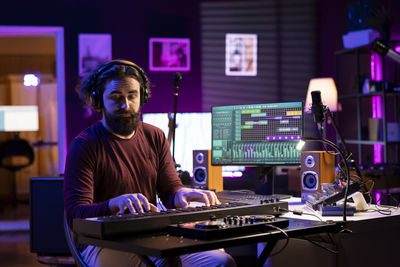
[174, 187, 221, 208]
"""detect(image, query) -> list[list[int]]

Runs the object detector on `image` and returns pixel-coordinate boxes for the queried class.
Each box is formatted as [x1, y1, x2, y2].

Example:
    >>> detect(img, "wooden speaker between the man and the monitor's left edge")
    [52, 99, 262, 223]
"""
[193, 150, 224, 192]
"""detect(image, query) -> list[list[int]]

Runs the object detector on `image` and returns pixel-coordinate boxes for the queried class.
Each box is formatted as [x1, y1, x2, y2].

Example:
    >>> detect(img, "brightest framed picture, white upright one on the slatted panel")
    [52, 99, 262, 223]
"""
[225, 33, 257, 76]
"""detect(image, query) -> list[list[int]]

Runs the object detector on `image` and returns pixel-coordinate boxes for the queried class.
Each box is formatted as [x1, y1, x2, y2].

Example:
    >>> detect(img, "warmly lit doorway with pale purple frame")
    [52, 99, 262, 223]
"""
[0, 26, 66, 203]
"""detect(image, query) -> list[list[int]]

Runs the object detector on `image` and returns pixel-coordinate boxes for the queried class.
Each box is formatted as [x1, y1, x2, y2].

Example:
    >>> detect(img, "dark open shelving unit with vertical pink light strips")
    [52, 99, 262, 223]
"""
[335, 41, 400, 165]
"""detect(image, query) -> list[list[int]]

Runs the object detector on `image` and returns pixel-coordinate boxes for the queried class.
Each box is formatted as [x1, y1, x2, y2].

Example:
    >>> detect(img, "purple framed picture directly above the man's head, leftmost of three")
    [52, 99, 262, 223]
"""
[79, 34, 112, 77]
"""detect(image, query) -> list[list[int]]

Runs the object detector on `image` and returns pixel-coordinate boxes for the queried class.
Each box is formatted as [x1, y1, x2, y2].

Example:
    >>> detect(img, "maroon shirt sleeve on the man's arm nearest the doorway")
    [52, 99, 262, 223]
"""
[64, 138, 110, 229]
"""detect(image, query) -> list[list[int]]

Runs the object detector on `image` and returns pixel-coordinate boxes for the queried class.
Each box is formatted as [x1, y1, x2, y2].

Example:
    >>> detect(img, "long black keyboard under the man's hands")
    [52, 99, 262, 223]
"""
[73, 201, 288, 239]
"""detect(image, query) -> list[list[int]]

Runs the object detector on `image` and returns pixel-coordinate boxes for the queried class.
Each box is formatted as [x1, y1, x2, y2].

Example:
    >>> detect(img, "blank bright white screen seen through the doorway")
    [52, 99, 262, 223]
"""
[0, 105, 39, 132]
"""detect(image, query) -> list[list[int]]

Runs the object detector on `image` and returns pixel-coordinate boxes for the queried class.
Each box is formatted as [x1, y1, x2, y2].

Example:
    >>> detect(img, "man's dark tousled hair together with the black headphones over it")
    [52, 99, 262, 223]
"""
[75, 60, 151, 112]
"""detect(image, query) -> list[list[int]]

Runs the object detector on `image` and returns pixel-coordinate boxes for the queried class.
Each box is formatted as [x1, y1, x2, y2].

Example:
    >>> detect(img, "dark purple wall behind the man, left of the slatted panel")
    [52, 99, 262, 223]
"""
[0, 0, 201, 147]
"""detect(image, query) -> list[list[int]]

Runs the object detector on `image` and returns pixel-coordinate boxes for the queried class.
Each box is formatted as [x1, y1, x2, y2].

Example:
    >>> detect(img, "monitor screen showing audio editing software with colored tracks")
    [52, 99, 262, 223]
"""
[211, 101, 303, 166]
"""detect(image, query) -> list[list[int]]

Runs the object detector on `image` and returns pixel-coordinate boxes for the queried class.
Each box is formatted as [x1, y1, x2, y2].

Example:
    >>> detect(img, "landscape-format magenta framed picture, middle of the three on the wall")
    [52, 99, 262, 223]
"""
[149, 38, 190, 71]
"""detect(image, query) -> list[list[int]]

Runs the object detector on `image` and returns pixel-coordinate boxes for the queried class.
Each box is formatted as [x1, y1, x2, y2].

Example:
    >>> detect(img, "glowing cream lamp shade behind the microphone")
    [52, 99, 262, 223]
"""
[304, 78, 337, 113]
